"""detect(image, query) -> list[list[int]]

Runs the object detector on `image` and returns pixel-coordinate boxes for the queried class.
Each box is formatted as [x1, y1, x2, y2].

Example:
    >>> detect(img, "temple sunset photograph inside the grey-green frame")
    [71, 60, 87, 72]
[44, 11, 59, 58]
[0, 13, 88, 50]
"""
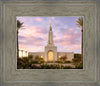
[17, 16, 83, 69]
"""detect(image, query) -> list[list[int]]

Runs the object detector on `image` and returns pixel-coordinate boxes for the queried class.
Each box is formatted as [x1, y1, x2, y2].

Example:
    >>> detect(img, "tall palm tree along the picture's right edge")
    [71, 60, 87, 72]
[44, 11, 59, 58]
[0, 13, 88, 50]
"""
[76, 17, 83, 61]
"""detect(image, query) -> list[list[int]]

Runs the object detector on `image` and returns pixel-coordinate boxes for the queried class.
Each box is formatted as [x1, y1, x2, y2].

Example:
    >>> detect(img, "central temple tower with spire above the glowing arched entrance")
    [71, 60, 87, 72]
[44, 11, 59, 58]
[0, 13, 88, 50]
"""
[44, 22, 57, 61]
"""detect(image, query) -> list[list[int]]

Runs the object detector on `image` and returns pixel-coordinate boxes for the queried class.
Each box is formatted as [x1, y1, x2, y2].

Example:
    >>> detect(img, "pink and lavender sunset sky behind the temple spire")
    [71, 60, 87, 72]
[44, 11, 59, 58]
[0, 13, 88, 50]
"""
[17, 17, 81, 53]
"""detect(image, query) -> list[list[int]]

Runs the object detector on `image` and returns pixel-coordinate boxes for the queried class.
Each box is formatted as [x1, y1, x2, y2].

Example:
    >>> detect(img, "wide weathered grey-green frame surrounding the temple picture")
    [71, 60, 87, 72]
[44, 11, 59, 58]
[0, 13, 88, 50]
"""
[1, 1, 100, 86]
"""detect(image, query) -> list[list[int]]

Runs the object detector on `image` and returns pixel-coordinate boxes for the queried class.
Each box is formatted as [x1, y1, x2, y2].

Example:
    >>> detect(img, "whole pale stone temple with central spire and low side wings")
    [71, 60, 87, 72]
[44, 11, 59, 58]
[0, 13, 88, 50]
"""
[28, 22, 74, 62]
